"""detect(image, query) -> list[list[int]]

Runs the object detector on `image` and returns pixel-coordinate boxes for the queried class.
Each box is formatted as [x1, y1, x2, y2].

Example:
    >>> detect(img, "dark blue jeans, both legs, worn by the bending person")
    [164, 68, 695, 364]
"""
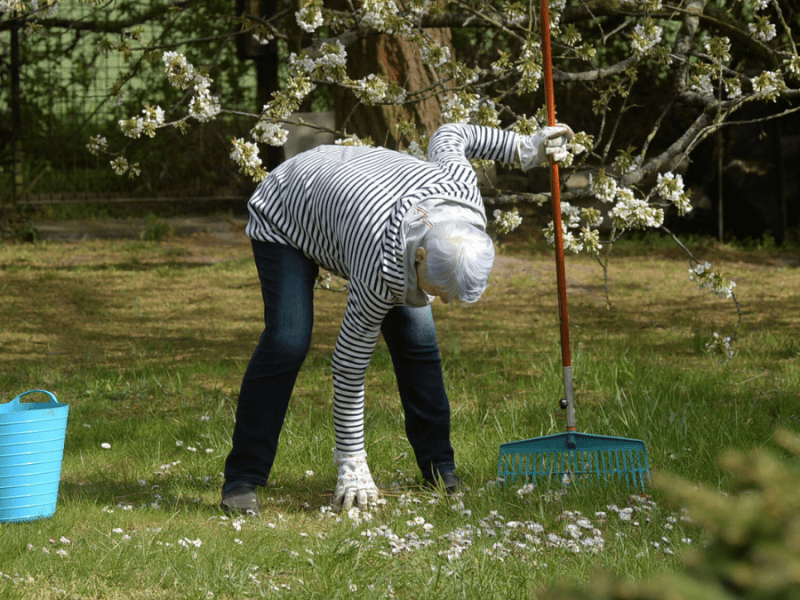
[225, 240, 455, 486]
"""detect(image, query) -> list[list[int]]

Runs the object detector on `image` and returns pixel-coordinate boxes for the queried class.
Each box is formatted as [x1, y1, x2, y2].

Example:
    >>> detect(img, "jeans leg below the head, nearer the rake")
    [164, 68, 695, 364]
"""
[381, 306, 455, 476]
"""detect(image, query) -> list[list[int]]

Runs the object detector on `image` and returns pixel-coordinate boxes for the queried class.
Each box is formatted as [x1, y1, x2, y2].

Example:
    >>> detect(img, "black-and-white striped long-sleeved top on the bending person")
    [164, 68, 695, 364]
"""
[246, 124, 519, 452]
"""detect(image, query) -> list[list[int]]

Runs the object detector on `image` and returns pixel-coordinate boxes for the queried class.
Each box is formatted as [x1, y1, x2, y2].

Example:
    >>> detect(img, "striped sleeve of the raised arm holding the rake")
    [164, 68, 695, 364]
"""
[428, 123, 519, 184]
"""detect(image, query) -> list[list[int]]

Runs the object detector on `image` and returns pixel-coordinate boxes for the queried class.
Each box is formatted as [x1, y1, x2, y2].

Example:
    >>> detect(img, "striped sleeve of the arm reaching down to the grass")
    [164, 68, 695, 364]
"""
[331, 281, 393, 452]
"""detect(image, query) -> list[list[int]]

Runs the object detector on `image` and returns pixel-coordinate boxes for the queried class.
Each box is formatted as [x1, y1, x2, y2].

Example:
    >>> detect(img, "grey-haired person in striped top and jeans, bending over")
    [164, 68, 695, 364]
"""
[221, 124, 572, 514]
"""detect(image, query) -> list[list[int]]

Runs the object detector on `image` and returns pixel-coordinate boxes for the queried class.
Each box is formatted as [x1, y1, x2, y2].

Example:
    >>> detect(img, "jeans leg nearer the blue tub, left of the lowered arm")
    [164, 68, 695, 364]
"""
[225, 240, 319, 486]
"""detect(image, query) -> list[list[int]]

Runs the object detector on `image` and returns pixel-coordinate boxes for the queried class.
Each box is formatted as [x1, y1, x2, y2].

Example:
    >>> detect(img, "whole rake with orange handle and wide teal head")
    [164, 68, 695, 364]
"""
[497, 0, 650, 490]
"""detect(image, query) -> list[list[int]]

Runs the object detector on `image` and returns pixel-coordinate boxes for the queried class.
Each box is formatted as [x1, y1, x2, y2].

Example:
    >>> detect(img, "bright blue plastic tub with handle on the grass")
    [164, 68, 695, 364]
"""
[0, 390, 69, 523]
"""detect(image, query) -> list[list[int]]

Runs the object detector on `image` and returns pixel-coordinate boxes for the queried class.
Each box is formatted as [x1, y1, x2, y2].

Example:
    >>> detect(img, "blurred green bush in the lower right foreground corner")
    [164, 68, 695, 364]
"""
[541, 431, 800, 600]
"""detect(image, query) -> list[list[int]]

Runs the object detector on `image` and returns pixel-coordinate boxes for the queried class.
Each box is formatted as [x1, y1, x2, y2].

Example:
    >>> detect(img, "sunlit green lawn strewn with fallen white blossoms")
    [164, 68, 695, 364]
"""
[0, 233, 800, 599]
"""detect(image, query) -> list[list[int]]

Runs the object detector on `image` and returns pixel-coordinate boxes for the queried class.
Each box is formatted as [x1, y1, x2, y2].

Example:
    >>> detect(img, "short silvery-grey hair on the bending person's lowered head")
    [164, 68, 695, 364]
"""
[422, 221, 494, 304]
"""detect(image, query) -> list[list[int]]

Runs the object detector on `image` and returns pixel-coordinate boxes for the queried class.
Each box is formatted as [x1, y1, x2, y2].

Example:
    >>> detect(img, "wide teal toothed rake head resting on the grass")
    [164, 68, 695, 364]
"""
[497, 432, 650, 490]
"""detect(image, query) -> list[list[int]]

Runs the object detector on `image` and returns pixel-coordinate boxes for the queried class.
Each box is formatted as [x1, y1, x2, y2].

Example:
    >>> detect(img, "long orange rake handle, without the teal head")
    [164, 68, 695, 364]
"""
[540, 0, 575, 431]
